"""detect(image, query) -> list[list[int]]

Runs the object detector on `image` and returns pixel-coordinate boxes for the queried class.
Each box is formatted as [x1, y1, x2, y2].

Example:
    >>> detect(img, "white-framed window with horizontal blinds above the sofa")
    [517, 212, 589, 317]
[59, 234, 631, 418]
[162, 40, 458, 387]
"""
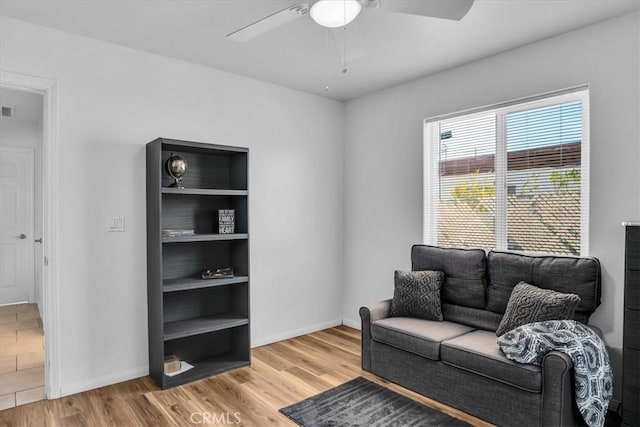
[424, 88, 589, 255]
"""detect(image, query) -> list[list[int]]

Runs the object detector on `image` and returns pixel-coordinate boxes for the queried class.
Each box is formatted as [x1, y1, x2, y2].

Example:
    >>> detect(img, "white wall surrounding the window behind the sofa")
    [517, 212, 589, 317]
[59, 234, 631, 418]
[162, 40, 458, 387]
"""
[343, 13, 640, 402]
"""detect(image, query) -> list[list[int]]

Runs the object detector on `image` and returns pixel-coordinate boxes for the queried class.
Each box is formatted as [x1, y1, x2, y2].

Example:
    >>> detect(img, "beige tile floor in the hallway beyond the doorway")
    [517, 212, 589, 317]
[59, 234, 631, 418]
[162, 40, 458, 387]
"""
[0, 304, 45, 410]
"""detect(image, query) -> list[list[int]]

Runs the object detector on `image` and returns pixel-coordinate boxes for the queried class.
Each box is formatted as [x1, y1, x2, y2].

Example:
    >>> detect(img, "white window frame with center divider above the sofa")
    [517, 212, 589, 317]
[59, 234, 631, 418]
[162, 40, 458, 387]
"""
[423, 85, 590, 256]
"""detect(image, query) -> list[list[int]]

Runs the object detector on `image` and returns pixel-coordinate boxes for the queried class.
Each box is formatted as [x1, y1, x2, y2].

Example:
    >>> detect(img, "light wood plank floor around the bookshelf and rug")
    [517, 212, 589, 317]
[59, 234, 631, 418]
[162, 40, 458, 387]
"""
[0, 326, 489, 427]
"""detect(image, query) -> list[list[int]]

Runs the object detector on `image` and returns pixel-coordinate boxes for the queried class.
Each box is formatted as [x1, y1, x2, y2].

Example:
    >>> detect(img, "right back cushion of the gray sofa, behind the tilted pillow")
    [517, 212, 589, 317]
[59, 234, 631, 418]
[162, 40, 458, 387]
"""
[488, 251, 600, 323]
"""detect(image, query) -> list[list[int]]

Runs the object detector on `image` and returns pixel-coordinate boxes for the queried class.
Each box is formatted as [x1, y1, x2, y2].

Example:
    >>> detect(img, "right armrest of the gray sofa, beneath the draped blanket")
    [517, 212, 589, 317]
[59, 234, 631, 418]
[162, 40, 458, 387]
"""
[541, 351, 582, 426]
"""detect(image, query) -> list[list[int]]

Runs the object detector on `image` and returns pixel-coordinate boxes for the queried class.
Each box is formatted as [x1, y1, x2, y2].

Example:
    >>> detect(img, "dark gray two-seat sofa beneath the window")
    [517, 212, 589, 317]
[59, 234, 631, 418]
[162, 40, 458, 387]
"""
[360, 245, 601, 427]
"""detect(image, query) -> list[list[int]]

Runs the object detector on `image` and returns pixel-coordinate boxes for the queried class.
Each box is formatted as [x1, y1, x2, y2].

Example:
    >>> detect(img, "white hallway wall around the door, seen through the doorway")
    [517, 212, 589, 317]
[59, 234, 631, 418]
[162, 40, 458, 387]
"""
[0, 88, 43, 313]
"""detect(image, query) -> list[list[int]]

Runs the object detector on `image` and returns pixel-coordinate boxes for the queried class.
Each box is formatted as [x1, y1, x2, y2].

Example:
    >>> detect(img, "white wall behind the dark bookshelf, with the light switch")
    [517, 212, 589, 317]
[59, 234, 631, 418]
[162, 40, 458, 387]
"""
[0, 17, 344, 395]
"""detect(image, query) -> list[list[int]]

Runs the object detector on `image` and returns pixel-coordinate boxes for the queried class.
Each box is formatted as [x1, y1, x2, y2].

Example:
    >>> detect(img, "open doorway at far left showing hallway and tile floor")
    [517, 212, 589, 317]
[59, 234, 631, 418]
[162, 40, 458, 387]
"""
[0, 87, 46, 409]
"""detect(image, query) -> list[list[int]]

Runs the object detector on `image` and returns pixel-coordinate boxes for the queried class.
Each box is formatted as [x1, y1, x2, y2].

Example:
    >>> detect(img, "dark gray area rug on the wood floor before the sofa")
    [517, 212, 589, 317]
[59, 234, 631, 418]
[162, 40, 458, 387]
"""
[280, 377, 469, 427]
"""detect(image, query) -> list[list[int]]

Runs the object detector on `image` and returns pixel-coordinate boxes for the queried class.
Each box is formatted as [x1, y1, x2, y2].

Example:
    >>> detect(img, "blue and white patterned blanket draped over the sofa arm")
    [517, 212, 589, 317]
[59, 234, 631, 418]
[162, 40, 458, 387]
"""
[498, 320, 613, 427]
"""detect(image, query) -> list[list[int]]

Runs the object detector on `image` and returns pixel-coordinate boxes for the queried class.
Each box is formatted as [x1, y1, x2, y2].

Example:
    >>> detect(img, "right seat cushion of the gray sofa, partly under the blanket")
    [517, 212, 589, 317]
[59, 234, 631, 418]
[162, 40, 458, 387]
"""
[440, 330, 542, 393]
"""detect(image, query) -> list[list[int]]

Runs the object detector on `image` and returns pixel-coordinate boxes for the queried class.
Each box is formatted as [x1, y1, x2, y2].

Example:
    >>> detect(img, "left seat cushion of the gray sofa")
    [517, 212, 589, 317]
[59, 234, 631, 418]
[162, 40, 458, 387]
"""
[371, 317, 476, 360]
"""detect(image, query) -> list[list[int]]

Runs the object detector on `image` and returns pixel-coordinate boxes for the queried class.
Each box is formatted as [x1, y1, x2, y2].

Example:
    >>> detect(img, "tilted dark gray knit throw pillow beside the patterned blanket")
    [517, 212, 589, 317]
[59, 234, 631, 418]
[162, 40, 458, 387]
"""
[496, 282, 580, 336]
